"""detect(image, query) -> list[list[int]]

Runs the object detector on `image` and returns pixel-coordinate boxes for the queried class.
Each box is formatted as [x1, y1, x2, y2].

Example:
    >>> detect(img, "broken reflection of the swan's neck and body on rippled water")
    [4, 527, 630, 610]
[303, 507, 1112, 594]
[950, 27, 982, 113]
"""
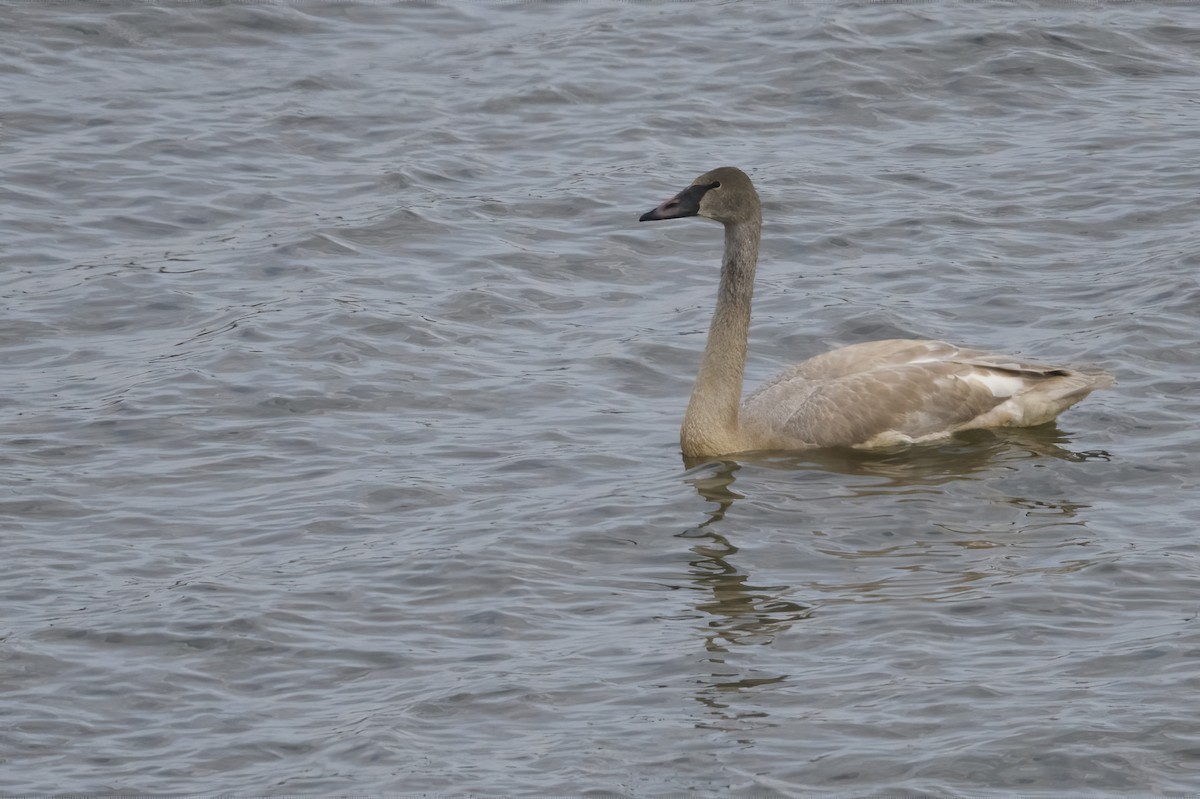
[677, 425, 1111, 731]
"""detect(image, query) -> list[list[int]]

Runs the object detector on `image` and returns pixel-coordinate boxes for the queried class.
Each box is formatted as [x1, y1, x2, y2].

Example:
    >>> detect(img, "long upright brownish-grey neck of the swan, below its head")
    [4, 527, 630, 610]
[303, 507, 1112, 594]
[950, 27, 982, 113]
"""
[679, 215, 762, 456]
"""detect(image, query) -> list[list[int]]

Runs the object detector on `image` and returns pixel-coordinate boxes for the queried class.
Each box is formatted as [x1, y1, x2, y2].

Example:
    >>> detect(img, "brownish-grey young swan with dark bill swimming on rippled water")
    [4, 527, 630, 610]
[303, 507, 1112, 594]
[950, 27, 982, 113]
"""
[640, 167, 1112, 458]
